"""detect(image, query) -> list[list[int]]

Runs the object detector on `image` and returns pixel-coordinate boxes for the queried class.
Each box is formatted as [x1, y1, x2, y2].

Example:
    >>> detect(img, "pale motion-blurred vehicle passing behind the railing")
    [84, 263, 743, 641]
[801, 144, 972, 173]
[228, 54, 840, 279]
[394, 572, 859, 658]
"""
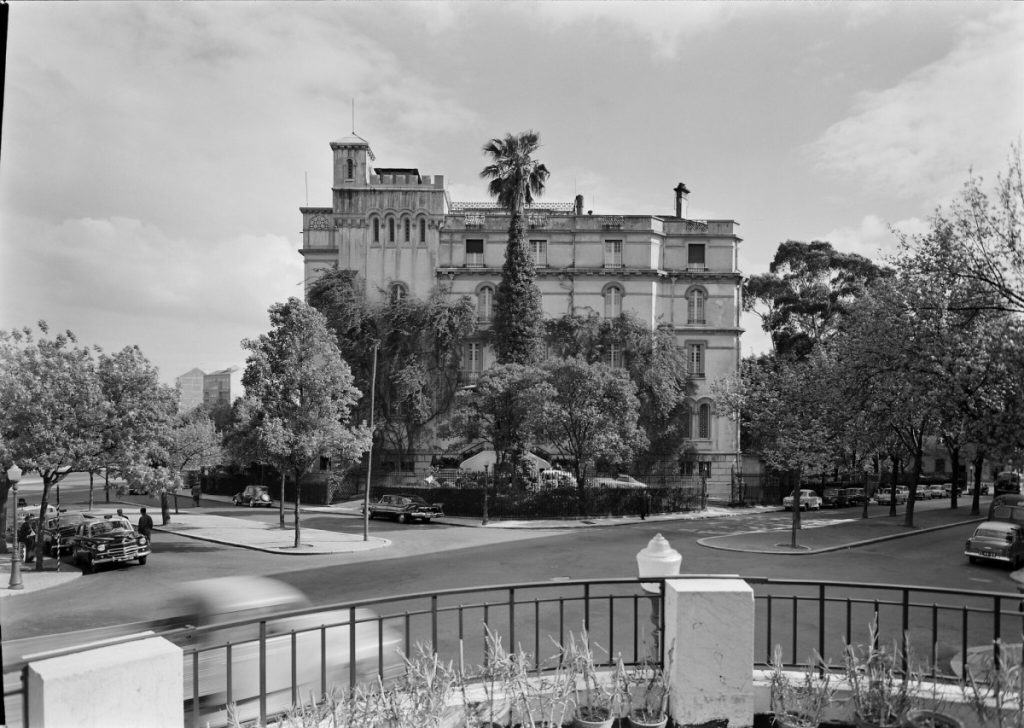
[174, 576, 403, 725]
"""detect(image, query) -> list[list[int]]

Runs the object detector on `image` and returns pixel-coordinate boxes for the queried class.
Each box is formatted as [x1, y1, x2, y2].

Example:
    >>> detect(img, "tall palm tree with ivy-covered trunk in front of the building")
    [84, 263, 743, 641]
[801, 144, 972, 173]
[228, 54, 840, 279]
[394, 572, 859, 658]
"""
[480, 131, 548, 365]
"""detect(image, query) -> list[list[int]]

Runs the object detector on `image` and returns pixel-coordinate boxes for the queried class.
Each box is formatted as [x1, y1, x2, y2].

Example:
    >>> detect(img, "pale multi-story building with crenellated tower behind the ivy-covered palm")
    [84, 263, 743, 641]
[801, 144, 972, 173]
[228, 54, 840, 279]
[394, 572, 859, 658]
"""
[300, 135, 742, 498]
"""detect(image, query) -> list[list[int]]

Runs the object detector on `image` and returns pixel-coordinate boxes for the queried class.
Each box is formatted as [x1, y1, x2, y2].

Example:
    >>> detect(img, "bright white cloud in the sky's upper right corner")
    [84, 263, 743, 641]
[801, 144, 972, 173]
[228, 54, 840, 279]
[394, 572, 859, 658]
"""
[804, 7, 1024, 204]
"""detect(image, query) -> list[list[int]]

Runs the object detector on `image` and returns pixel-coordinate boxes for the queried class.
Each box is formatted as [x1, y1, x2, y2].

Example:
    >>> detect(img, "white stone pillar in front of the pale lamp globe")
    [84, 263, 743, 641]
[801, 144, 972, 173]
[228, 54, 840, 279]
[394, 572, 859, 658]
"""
[665, 579, 754, 728]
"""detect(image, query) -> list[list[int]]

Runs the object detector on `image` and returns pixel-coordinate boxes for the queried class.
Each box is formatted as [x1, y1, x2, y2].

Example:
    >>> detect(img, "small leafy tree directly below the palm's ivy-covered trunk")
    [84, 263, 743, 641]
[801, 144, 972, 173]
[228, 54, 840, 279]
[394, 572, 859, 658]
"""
[447, 365, 554, 478]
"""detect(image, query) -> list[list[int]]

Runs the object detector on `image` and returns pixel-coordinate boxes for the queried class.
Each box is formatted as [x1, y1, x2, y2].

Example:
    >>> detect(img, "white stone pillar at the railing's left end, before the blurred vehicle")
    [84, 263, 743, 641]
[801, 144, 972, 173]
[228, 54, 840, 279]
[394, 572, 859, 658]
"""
[28, 637, 185, 728]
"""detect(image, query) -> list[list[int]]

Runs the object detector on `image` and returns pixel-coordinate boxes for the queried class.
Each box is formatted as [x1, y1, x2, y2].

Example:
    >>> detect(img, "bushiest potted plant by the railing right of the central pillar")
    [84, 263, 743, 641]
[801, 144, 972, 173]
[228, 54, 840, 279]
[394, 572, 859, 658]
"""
[843, 624, 916, 728]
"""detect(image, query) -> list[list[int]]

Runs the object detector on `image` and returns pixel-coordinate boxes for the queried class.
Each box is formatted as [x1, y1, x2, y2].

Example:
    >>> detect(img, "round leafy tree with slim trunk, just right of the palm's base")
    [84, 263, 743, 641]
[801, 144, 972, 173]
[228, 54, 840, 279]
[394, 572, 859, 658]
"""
[538, 358, 645, 514]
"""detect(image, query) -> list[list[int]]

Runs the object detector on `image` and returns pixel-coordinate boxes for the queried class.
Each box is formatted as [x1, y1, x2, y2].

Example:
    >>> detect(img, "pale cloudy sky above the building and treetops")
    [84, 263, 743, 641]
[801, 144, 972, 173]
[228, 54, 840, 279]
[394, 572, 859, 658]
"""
[0, 0, 1024, 383]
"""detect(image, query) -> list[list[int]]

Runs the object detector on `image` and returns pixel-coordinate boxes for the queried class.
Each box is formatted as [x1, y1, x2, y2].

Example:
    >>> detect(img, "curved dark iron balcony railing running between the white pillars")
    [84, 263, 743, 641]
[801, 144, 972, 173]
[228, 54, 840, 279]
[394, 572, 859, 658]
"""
[4, 574, 1024, 726]
